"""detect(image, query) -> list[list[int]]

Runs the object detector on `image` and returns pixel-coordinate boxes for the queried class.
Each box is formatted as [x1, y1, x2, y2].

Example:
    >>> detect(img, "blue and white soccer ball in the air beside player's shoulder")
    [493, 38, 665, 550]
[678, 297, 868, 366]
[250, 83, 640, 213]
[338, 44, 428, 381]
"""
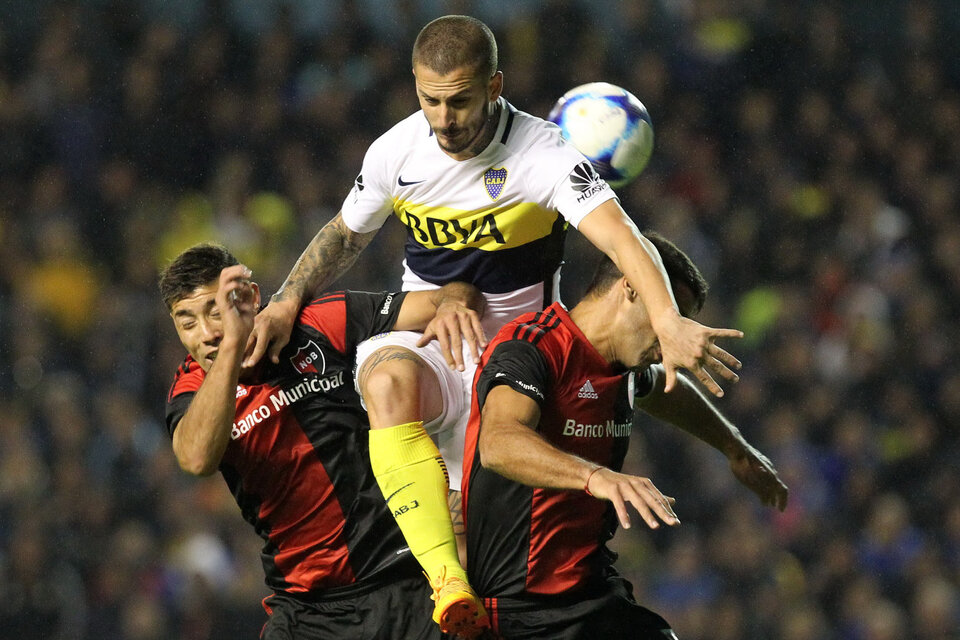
[549, 82, 653, 187]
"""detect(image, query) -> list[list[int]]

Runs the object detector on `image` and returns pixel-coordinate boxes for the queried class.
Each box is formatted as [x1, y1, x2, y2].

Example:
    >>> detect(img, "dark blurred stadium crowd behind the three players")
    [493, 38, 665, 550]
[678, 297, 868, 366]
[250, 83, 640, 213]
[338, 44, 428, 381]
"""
[0, 0, 960, 640]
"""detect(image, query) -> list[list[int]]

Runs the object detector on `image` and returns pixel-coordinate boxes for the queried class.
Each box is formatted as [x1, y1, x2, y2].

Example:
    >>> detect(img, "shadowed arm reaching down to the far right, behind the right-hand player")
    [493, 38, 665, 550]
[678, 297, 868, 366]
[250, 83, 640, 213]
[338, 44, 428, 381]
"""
[639, 368, 789, 511]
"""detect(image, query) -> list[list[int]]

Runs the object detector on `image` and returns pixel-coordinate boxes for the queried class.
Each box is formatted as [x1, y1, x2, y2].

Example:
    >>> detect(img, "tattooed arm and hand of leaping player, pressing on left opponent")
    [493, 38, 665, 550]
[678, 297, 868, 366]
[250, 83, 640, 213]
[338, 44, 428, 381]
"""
[243, 213, 377, 367]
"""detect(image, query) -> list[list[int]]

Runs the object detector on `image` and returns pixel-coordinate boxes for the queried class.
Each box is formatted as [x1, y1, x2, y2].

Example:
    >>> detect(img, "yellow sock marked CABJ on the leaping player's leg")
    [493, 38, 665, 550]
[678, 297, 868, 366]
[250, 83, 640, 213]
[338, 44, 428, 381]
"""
[370, 422, 467, 582]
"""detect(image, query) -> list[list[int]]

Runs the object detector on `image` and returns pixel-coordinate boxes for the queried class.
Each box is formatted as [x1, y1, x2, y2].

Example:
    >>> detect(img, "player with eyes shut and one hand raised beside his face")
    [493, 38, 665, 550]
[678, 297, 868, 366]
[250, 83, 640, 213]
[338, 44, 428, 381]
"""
[160, 245, 481, 640]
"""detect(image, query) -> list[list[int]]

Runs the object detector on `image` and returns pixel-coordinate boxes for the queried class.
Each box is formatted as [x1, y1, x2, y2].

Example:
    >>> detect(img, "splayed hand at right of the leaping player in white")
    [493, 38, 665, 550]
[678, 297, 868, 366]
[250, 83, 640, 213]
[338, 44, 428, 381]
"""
[654, 313, 743, 398]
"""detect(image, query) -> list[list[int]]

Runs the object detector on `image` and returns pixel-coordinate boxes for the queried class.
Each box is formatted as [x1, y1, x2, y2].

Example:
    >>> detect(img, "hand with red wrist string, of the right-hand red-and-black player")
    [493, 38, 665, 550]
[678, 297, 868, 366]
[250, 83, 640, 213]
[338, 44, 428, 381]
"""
[587, 467, 680, 529]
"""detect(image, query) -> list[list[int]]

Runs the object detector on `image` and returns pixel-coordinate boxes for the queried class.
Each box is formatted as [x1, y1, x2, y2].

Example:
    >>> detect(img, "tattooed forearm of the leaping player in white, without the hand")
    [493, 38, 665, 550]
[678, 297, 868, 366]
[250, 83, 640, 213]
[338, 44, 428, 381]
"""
[271, 215, 373, 302]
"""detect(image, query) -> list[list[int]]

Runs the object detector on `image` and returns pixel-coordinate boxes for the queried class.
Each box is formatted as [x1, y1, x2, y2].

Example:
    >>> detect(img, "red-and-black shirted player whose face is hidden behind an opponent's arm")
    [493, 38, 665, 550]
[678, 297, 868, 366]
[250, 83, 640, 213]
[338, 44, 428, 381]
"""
[463, 234, 787, 640]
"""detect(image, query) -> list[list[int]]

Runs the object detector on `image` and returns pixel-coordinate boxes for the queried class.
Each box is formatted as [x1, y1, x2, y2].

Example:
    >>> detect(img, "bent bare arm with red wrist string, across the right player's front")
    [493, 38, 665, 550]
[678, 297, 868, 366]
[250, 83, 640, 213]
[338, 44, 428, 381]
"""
[479, 385, 680, 529]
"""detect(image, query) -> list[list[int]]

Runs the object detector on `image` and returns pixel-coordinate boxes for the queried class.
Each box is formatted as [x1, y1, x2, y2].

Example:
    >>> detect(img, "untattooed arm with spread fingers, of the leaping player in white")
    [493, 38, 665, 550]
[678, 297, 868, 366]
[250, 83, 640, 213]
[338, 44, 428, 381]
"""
[578, 200, 743, 396]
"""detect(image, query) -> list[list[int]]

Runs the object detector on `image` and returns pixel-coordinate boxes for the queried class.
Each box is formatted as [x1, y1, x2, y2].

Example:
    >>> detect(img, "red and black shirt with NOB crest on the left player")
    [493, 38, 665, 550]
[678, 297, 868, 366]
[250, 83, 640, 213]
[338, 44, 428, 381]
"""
[166, 291, 413, 597]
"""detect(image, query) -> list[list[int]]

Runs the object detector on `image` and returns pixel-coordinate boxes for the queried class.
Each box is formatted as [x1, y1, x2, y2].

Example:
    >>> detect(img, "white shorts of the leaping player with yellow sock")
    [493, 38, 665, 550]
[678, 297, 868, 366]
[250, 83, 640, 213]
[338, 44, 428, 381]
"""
[354, 331, 477, 491]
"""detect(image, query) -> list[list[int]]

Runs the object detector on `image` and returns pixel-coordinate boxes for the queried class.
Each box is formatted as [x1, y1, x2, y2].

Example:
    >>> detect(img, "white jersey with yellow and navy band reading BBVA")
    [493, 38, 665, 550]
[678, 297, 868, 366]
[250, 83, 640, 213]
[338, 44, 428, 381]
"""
[342, 98, 616, 335]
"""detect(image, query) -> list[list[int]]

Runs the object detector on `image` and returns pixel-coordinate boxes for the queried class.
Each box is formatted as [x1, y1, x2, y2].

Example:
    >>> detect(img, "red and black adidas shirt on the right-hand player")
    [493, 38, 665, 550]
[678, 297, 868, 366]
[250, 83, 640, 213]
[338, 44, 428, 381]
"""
[463, 303, 653, 598]
